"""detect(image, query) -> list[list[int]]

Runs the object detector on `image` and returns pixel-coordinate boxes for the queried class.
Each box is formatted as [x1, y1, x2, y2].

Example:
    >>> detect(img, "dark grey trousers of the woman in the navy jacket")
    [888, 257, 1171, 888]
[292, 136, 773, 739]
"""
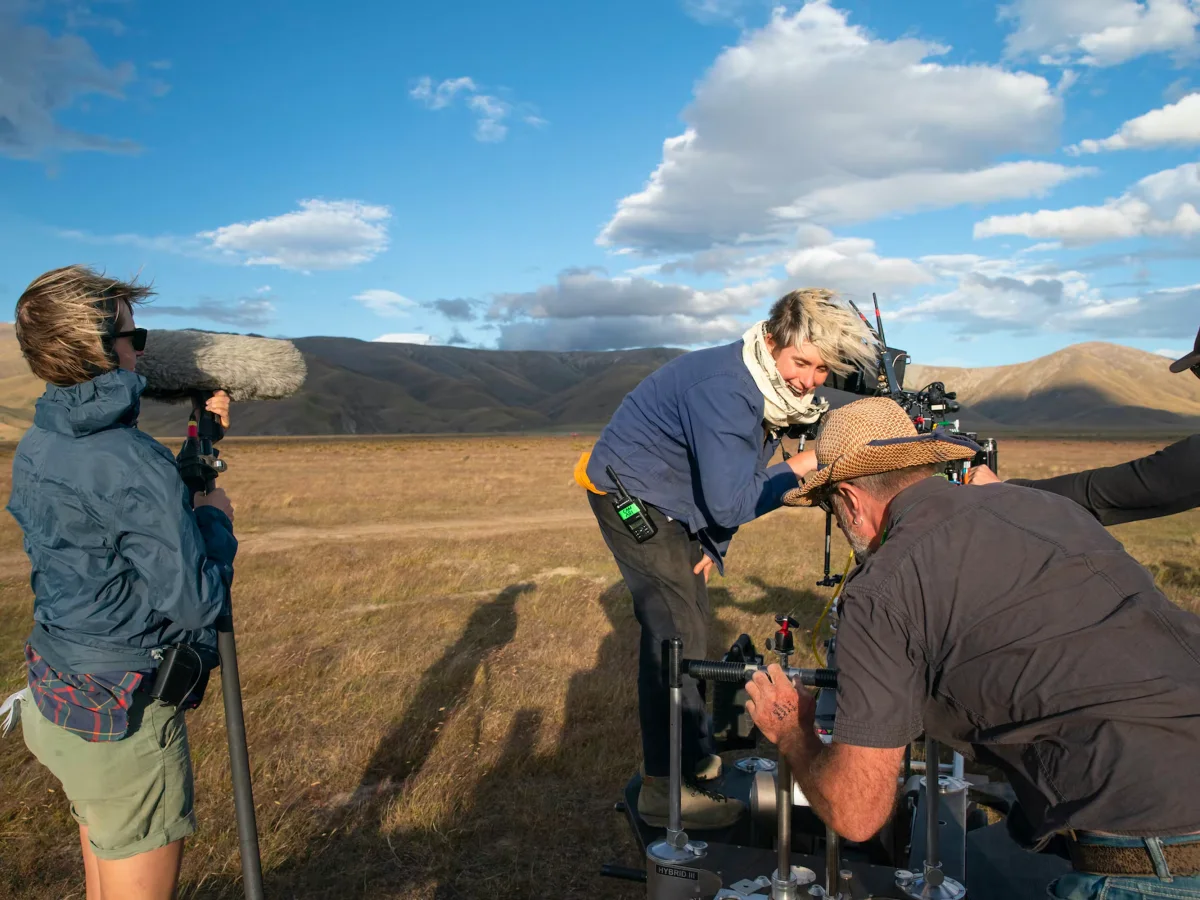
[588, 491, 713, 776]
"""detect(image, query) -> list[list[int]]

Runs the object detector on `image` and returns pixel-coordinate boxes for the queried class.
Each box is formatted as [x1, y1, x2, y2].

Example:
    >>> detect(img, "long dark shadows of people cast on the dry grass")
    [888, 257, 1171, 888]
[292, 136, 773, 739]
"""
[181, 582, 820, 900]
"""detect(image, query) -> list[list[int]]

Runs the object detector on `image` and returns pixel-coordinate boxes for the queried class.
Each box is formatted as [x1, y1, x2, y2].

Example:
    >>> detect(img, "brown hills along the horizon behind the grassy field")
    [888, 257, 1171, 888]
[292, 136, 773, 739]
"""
[0, 325, 1200, 439]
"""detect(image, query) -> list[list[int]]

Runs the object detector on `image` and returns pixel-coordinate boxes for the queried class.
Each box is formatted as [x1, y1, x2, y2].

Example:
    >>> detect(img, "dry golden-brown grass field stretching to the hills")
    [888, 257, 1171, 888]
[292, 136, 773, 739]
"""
[0, 438, 1200, 900]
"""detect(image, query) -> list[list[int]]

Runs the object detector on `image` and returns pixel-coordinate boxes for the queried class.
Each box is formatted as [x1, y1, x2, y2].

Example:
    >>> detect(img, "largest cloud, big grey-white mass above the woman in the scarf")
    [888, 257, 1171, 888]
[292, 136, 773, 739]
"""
[598, 0, 1081, 254]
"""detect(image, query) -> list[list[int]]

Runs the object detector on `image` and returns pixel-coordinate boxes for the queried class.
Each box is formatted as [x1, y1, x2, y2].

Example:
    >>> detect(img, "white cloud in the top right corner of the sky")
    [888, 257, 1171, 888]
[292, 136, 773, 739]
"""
[1001, 0, 1200, 66]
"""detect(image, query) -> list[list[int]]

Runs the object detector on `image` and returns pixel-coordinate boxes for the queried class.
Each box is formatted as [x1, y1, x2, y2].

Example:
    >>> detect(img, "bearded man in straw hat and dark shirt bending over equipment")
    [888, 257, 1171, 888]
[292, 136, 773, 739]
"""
[746, 397, 1200, 900]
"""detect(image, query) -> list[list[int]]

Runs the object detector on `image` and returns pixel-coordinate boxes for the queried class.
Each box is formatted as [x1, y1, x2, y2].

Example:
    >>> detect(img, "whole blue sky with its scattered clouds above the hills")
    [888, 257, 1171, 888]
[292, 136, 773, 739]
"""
[0, 0, 1200, 365]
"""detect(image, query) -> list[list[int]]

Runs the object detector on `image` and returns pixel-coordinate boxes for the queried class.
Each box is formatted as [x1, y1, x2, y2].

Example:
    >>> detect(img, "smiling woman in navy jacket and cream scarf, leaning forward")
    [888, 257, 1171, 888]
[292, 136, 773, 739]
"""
[577, 289, 876, 828]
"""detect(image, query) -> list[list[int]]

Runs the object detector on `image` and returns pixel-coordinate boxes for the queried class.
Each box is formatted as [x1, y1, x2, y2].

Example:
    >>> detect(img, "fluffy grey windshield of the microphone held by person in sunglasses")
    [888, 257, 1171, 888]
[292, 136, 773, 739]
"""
[137, 330, 308, 403]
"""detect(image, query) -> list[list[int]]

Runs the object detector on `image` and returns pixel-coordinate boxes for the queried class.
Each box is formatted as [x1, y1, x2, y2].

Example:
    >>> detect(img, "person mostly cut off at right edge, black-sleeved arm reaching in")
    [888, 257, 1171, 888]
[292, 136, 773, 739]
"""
[967, 321, 1200, 524]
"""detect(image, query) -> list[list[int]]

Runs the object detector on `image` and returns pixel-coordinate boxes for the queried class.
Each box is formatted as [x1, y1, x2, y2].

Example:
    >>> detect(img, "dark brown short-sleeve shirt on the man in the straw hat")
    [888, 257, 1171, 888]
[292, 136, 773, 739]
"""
[834, 478, 1200, 836]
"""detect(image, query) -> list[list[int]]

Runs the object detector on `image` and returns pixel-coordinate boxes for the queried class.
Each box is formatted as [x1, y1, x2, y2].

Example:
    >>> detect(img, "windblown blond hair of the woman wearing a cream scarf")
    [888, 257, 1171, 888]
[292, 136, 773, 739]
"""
[767, 288, 878, 376]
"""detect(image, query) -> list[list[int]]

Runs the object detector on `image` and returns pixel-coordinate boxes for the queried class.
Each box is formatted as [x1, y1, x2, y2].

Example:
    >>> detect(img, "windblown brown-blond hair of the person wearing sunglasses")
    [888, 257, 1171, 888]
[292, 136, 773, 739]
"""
[14, 265, 154, 386]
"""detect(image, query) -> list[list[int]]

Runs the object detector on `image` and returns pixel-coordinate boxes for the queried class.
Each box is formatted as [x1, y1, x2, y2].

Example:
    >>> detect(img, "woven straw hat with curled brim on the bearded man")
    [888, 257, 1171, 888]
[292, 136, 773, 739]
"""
[784, 397, 980, 506]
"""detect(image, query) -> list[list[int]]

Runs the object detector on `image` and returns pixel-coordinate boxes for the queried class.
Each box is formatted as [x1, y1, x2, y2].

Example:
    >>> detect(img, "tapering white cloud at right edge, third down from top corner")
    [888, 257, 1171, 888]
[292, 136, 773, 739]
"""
[974, 162, 1200, 245]
